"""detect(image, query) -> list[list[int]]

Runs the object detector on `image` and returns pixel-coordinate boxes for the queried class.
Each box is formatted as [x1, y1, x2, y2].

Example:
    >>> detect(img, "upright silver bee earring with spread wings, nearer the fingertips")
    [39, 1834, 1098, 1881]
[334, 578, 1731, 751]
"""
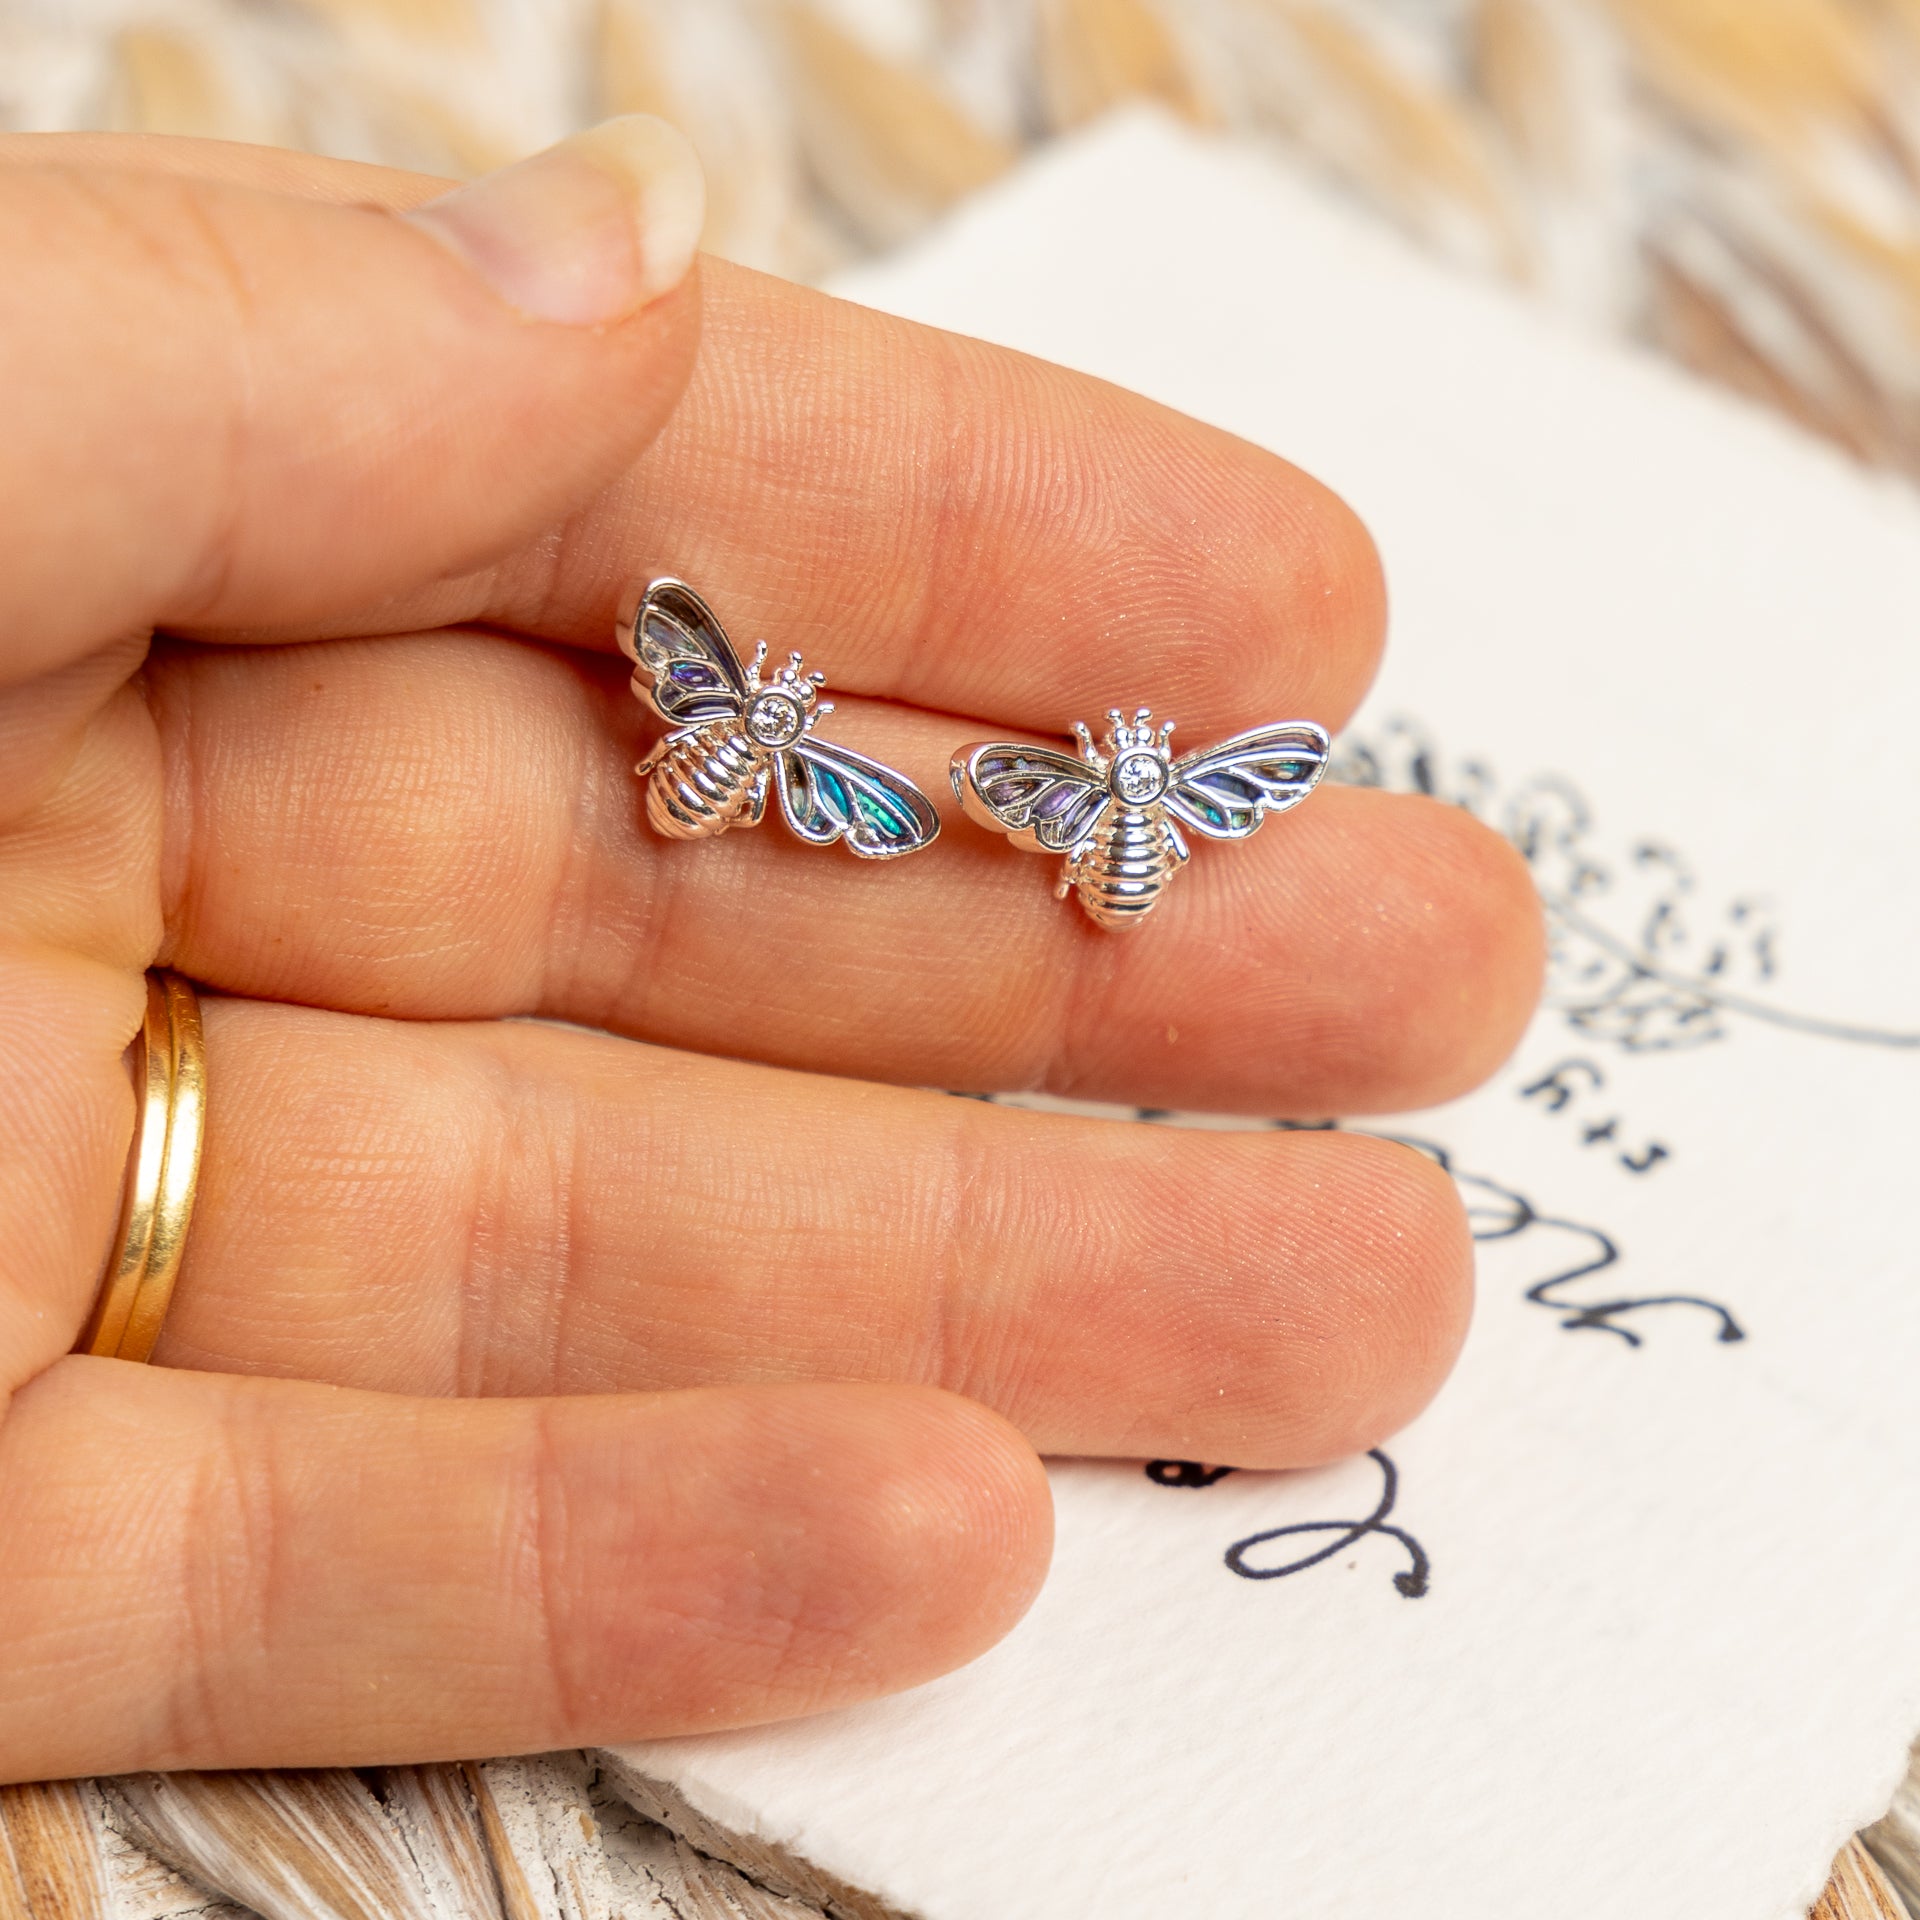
[952, 707, 1327, 927]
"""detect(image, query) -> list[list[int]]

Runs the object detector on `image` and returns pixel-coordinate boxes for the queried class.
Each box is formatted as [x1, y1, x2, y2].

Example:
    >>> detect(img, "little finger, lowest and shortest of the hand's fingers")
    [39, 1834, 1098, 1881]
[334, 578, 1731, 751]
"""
[0, 1359, 1048, 1780]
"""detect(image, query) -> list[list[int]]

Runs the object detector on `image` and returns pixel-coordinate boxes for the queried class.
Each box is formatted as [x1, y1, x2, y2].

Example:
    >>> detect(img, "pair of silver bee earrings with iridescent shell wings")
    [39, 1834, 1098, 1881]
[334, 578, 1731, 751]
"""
[618, 580, 1327, 927]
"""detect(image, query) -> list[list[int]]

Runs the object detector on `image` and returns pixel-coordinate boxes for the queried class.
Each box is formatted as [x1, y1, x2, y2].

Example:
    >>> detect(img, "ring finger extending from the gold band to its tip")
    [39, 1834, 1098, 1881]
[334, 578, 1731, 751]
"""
[159, 1000, 1471, 1467]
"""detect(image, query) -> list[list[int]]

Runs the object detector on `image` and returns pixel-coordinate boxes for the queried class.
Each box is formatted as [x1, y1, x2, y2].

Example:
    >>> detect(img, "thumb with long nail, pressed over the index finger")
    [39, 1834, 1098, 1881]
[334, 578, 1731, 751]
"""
[0, 115, 703, 684]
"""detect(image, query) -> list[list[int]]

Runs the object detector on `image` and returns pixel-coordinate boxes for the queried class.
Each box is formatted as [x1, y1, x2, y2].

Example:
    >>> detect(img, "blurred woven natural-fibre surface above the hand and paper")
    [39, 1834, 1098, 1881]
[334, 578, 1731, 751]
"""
[0, 0, 1920, 474]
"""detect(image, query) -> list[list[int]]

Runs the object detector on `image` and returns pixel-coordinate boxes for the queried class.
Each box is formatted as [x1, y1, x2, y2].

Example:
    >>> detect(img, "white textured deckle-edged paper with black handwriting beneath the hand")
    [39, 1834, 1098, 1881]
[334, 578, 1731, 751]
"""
[610, 121, 1920, 1920]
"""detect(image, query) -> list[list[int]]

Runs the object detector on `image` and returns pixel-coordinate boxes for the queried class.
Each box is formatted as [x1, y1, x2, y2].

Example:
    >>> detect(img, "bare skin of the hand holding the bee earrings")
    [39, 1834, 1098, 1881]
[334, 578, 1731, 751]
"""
[0, 136, 1540, 1778]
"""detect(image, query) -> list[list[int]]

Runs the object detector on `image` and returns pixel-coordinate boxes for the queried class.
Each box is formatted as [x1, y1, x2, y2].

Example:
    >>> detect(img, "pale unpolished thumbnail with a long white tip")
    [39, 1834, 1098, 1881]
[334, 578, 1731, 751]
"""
[405, 113, 707, 326]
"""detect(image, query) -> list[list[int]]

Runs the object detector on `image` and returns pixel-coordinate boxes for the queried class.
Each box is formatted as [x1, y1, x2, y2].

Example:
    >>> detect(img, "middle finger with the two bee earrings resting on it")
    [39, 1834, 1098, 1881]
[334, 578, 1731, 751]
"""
[150, 636, 1540, 1114]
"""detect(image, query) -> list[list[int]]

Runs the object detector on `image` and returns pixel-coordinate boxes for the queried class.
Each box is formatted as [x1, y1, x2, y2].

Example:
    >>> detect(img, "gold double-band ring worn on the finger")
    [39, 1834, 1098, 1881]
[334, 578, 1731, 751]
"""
[73, 968, 207, 1359]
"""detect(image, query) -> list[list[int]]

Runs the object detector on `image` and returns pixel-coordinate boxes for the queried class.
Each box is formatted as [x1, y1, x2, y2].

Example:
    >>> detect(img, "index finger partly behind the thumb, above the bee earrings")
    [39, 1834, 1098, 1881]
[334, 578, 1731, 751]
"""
[0, 131, 1384, 737]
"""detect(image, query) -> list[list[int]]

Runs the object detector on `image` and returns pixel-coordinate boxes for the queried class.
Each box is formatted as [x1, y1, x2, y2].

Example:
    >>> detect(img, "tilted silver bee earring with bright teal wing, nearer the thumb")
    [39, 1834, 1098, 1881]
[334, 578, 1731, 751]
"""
[618, 580, 941, 860]
